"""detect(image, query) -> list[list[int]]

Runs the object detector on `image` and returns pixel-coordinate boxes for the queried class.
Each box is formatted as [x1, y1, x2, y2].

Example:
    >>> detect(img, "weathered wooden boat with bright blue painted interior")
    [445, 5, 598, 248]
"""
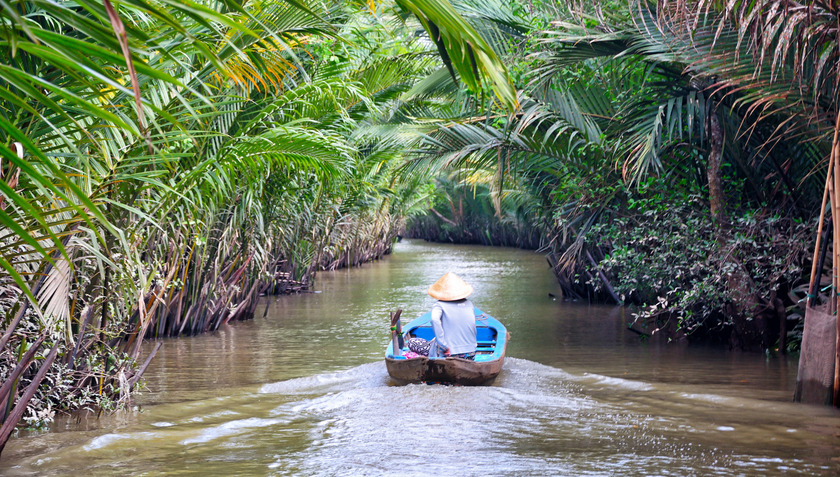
[385, 308, 510, 386]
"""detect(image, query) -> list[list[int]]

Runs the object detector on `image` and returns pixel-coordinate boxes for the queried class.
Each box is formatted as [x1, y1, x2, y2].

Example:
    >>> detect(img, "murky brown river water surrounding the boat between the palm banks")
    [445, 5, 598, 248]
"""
[0, 240, 840, 476]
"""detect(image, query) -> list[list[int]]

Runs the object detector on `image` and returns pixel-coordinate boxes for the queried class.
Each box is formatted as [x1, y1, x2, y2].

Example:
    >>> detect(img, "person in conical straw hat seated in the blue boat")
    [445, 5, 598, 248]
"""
[408, 272, 477, 360]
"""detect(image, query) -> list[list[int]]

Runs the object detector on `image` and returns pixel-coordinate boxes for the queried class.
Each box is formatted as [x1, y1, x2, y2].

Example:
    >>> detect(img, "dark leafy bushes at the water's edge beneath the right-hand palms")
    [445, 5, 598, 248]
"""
[585, 188, 813, 349]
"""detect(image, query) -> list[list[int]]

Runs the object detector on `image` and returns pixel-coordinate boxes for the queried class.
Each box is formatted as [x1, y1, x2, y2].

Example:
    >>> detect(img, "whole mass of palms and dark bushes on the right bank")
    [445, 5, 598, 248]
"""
[410, 0, 840, 349]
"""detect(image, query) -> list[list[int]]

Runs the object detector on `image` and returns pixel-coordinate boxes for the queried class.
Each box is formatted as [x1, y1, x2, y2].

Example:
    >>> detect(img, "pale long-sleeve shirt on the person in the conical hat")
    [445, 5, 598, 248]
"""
[431, 299, 477, 354]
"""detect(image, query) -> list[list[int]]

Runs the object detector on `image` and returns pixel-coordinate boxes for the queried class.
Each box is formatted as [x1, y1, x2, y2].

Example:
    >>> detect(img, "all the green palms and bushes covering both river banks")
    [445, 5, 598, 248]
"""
[0, 0, 840, 443]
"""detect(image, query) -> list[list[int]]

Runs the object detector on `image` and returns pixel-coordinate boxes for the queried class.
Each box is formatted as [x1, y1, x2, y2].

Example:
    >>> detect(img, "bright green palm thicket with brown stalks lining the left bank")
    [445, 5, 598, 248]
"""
[0, 0, 466, 443]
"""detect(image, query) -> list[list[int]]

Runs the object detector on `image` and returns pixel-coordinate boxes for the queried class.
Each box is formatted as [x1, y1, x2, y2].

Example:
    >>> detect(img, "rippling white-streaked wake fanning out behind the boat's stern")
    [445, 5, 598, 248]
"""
[3, 358, 838, 476]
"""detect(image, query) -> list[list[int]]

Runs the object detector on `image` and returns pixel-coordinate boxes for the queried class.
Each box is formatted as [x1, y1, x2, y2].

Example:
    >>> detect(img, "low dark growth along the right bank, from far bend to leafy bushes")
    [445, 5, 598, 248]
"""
[407, 189, 812, 354]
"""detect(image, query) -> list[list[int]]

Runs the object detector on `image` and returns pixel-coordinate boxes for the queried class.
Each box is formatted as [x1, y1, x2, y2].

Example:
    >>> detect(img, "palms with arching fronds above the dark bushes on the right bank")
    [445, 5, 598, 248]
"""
[394, 2, 834, 346]
